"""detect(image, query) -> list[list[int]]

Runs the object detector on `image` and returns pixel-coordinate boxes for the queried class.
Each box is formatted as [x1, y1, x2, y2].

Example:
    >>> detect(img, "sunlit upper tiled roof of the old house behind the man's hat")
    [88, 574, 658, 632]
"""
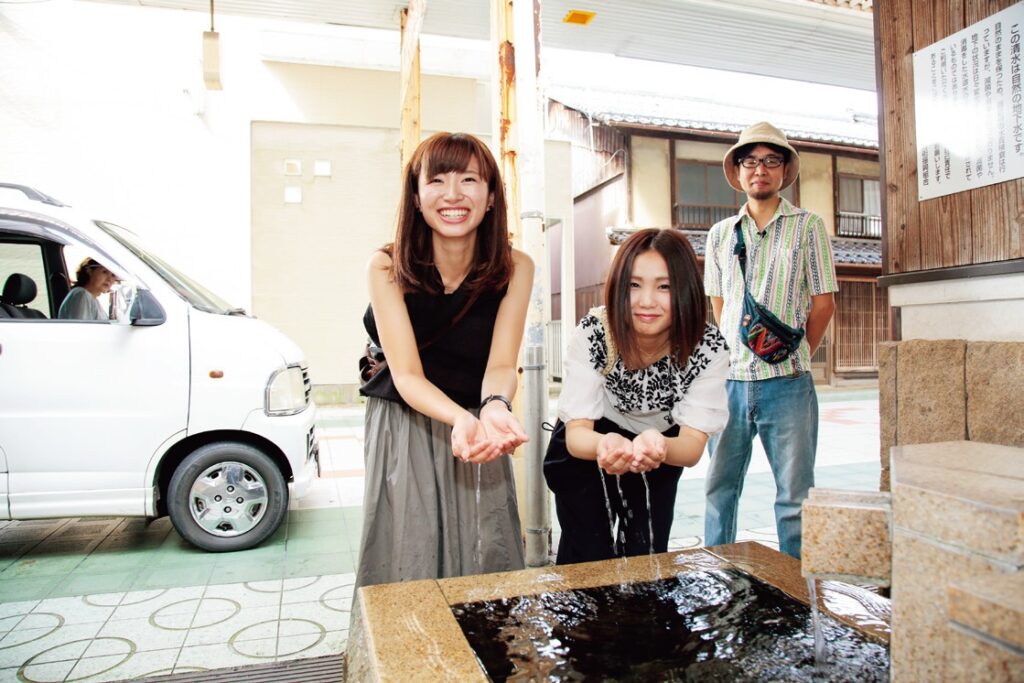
[546, 87, 879, 150]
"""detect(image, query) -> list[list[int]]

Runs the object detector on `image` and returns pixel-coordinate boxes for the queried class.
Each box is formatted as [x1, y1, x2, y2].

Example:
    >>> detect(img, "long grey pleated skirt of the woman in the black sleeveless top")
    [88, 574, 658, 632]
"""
[355, 396, 524, 588]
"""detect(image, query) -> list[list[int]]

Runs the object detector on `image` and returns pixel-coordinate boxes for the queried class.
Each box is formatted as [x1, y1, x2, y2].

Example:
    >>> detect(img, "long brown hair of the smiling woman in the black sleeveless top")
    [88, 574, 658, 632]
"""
[384, 133, 512, 294]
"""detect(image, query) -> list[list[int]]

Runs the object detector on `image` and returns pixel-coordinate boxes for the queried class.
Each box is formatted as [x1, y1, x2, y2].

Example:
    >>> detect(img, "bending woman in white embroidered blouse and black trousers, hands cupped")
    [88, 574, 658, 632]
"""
[544, 229, 729, 564]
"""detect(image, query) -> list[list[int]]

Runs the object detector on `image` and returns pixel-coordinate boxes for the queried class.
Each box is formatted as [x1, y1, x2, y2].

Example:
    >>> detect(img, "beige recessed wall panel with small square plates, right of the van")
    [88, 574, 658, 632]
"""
[252, 123, 400, 384]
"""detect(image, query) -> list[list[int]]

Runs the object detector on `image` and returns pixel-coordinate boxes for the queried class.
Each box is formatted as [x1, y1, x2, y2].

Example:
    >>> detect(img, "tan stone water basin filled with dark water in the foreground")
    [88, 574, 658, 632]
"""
[346, 543, 890, 681]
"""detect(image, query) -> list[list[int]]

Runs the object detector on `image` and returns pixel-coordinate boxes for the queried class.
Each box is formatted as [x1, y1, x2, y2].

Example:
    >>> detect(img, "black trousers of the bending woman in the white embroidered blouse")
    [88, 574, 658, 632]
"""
[544, 419, 683, 564]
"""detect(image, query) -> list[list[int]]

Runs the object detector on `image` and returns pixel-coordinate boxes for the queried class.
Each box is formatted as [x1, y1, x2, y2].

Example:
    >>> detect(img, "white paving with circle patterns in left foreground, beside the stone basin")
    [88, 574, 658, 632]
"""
[0, 574, 354, 683]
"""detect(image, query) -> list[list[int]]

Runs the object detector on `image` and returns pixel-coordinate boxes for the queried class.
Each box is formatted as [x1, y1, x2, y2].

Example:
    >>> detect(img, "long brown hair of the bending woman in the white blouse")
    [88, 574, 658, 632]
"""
[604, 227, 708, 370]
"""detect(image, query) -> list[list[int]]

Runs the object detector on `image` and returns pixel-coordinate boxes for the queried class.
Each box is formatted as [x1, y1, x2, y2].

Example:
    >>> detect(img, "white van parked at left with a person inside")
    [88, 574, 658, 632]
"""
[0, 183, 318, 551]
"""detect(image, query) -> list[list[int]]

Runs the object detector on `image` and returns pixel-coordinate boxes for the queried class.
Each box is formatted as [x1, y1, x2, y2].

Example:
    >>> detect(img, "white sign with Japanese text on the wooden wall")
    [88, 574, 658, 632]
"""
[913, 2, 1024, 200]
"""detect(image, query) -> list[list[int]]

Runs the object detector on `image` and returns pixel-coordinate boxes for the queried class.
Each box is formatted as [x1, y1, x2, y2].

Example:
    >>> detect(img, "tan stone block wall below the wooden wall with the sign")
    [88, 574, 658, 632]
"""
[879, 339, 1024, 490]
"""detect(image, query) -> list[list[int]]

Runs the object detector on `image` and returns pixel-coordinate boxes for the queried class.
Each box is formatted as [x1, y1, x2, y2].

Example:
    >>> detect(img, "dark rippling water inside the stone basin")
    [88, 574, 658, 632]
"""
[453, 568, 889, 682]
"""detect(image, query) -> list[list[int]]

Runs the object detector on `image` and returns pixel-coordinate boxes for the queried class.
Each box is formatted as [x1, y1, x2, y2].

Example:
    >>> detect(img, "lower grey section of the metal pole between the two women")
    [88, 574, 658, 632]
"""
[522, 344, 551, 567]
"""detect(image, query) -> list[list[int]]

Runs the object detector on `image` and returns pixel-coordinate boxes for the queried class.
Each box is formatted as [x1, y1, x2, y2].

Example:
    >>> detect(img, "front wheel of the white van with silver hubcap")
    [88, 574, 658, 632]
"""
[167, 442, 288, 552]
